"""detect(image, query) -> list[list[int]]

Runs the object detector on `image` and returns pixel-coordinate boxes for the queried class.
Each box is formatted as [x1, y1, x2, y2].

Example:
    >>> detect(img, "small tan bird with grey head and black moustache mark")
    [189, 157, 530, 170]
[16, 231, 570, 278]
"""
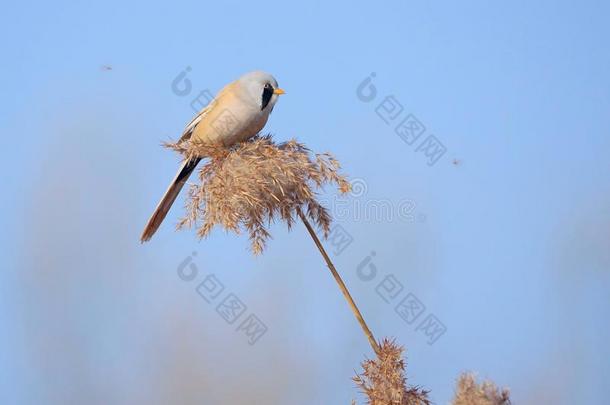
[140, 71, 285, 243]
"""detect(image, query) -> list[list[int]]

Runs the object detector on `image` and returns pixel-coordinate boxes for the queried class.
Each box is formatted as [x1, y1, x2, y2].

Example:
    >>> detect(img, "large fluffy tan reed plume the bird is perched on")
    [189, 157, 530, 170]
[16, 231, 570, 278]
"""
[166, 136, 351, 255]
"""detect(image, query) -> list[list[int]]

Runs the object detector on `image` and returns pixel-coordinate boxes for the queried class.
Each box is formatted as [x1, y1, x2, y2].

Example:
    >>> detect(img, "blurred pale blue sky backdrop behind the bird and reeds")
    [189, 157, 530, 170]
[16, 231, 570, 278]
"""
[0, 0, 610, 404]
